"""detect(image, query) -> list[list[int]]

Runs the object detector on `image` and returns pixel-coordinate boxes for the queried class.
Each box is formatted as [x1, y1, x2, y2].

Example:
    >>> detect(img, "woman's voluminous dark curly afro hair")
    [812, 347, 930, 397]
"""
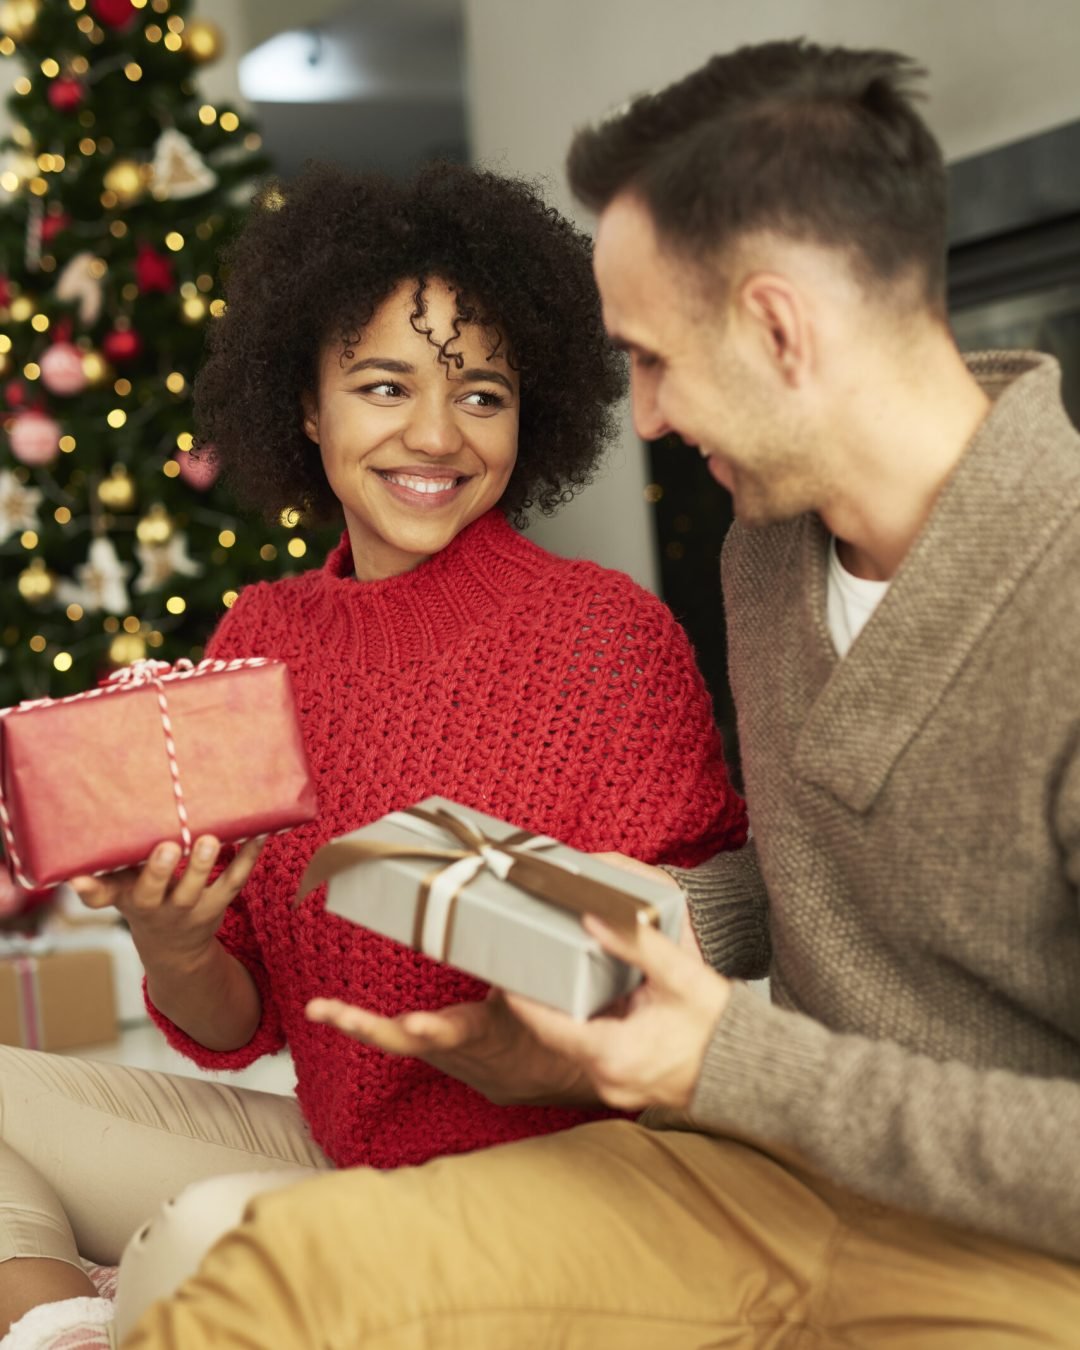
[194, 163, 626, 525]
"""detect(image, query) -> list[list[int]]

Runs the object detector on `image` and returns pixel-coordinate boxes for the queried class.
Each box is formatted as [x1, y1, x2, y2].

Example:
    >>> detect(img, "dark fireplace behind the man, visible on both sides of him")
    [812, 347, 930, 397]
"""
[647, 122, 1080, 776]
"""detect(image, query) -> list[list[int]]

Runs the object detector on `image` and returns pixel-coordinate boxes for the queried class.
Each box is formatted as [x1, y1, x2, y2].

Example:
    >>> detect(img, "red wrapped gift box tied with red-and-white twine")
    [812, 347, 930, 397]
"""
[0, 659, 316, 887]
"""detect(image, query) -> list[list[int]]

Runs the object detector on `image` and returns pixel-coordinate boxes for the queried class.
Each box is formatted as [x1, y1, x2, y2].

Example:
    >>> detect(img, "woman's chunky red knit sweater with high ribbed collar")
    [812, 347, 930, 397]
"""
[151, 510, 745, 1168]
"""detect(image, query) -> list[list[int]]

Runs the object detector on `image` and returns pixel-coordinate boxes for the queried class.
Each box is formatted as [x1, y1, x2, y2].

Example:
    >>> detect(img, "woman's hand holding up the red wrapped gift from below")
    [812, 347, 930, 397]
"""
[70, 834, 263, 968]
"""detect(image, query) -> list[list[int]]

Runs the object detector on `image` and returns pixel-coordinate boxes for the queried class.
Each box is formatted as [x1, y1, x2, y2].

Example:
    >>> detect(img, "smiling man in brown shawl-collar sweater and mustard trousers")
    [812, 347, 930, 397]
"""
[120, 42, 1080, 1350]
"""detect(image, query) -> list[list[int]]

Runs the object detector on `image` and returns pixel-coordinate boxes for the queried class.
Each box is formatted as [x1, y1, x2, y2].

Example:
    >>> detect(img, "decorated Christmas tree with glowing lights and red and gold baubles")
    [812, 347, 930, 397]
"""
[0, 0, 334, 706]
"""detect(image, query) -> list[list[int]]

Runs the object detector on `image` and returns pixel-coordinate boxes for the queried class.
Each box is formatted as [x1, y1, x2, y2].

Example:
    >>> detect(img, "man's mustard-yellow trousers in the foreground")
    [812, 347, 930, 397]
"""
[123, 1122, 1080, 1350]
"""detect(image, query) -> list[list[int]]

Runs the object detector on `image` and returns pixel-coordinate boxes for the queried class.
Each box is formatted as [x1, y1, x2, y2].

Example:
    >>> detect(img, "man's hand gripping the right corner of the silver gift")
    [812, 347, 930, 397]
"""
[506, 915, 732, 1111]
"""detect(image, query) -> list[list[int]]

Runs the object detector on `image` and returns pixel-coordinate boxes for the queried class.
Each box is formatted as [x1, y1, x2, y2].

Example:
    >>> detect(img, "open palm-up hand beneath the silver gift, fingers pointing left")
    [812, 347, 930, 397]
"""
[306, 990, 599, 1106]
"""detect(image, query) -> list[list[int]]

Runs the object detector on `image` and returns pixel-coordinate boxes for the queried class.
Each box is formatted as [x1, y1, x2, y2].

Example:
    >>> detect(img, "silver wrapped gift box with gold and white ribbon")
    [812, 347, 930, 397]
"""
[300, 797, 683, 1018]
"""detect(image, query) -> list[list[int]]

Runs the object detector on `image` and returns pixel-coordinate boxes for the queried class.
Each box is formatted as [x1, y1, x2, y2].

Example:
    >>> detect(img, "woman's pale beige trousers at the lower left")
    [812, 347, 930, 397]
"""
[0, 1045, 331, 1328]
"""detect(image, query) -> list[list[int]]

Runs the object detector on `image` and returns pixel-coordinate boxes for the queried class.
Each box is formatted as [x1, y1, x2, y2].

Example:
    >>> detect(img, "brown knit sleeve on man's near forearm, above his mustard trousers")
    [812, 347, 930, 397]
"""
[691, 984, 1080, 1260]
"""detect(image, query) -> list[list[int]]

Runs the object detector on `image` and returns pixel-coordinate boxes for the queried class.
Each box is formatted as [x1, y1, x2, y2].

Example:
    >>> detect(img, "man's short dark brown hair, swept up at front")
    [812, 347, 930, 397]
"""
[567, 39, 946, 312]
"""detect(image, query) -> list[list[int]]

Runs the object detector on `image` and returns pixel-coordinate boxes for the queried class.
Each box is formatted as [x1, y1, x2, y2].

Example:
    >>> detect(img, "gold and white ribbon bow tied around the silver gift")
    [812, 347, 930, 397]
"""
[293, 806, 660, 961]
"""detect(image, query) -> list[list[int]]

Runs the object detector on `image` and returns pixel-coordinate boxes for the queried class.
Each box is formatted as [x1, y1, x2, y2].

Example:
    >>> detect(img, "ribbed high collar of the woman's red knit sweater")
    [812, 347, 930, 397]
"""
[305, 508, 554, 671]
